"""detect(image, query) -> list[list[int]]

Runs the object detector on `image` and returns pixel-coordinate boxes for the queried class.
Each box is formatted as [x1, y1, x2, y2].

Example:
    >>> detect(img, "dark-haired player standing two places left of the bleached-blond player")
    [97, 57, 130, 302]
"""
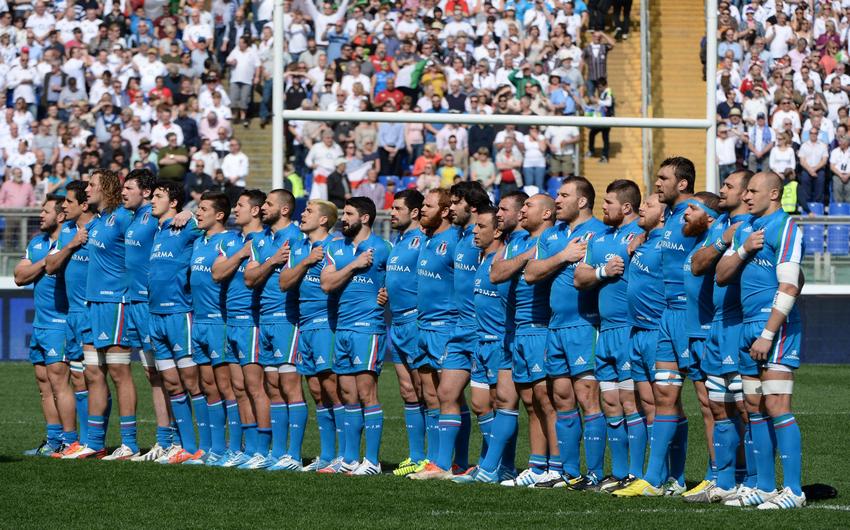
[210, 190, 266, 467]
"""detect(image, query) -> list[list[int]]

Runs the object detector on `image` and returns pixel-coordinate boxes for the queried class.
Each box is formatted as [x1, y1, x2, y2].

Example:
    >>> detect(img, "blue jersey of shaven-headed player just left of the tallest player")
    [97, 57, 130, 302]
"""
[626, 228, 667, 329]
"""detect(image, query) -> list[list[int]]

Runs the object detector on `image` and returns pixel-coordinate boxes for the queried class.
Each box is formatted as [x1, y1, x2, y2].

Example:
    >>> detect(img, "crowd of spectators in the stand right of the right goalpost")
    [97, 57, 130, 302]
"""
[715, 0, 850, 210]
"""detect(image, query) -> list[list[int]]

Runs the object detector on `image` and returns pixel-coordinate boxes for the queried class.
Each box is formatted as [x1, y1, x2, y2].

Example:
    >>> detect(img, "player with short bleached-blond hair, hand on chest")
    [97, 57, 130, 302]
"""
[282, 200, 342, 471]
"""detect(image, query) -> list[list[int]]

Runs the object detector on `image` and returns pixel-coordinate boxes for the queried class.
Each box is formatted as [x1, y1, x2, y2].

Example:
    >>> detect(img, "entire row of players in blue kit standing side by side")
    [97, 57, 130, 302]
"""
[15, 157, 805, 509]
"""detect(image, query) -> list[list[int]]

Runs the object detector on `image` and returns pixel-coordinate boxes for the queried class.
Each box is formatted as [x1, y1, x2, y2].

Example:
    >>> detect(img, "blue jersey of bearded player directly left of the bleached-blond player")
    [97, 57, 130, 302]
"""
[251, 223, 304, 326]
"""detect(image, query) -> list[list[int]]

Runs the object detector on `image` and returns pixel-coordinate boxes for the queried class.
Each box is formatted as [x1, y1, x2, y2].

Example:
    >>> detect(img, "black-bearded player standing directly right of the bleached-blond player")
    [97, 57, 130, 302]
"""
[321, 197, 390, 475]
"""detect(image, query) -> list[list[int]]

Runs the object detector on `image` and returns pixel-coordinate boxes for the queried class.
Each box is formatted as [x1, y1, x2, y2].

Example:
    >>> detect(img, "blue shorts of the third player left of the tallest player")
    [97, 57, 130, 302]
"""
[546, 324, 599, 377]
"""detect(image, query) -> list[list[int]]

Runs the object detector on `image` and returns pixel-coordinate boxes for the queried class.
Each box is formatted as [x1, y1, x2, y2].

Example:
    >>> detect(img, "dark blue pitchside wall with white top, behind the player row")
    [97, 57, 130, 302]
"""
[0, 278, 850, 364]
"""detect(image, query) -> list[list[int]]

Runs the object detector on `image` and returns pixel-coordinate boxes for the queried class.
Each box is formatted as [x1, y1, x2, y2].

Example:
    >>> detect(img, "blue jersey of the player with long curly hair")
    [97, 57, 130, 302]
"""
[86, 206, 133, 303]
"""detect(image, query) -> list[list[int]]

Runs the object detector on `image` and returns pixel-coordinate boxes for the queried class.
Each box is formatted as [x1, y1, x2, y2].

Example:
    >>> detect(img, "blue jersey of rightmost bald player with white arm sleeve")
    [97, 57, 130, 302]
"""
[734, 210, 803, 322]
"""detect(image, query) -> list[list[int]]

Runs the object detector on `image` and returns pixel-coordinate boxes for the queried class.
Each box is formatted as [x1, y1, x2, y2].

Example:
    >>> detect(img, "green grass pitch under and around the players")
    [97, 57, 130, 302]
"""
[0, 363, 850, 529]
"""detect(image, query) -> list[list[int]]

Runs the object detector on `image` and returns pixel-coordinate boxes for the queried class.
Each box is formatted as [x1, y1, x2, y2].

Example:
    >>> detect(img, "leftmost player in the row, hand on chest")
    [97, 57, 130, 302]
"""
[14, 195, 73, 456]
